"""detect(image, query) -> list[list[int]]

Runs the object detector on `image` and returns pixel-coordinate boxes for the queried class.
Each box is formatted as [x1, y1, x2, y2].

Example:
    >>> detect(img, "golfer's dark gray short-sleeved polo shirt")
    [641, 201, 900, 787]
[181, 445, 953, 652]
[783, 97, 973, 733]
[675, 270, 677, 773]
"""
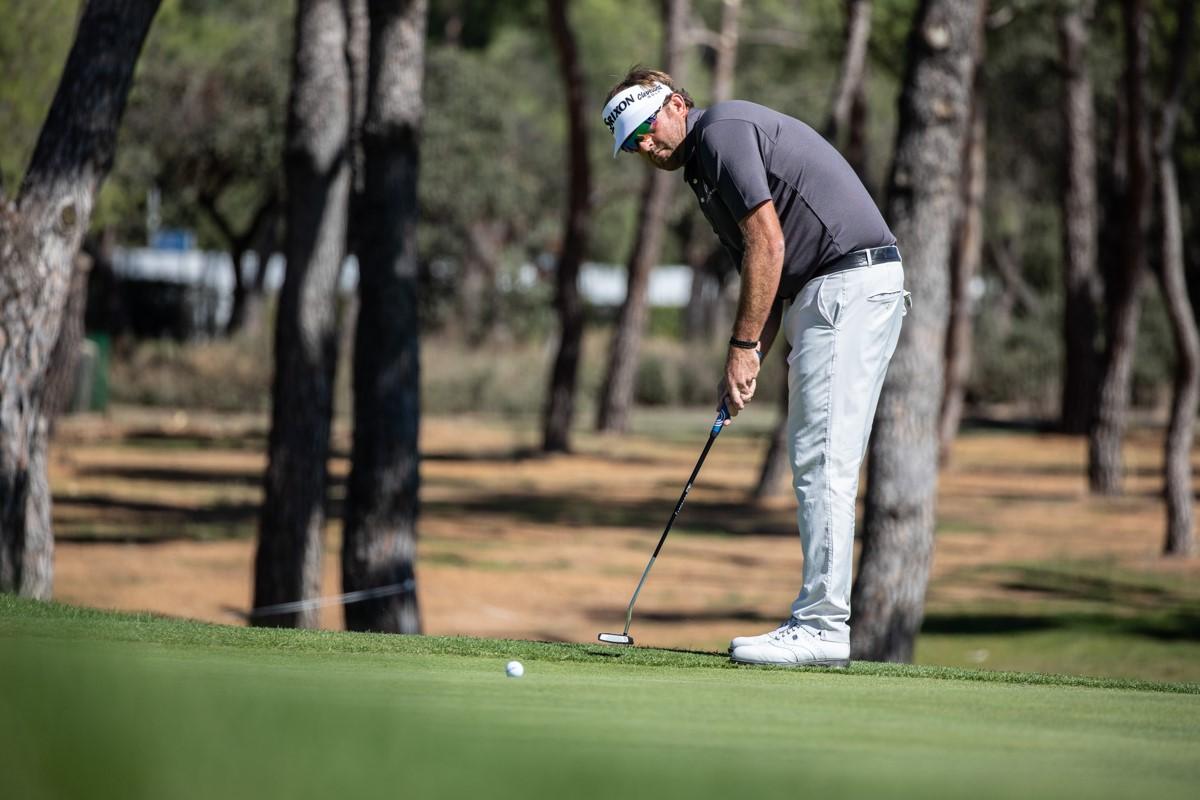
[683, 100, 896, 297]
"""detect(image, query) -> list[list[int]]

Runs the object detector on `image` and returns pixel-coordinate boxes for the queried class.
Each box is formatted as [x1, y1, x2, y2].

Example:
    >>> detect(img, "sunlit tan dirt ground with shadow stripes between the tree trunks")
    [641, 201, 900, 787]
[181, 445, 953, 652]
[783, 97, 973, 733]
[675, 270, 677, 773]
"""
[50, 408, 1200, 649]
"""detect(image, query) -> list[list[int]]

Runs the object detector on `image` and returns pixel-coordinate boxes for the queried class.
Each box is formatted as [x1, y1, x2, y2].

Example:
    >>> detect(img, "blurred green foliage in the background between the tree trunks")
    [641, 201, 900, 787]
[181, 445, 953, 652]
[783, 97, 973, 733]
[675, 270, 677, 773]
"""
[0, 0, 1200, 415]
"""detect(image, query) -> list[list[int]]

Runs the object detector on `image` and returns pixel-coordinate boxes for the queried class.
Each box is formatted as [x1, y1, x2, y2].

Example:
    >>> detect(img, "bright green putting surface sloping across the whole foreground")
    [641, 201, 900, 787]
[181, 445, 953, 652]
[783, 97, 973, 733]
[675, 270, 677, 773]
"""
[0, 596, 1200, 799]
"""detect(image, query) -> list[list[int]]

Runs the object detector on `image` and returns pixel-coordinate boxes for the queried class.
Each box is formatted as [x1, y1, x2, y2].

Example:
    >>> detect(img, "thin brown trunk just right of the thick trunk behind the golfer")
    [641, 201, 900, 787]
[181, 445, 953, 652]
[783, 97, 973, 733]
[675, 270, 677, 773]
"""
[938, 10, 988, 465]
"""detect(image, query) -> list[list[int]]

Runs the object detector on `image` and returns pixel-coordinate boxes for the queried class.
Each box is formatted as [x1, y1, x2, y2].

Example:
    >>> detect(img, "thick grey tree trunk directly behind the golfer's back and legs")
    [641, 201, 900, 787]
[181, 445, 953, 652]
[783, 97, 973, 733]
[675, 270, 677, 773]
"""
[852, 0, 983, 661]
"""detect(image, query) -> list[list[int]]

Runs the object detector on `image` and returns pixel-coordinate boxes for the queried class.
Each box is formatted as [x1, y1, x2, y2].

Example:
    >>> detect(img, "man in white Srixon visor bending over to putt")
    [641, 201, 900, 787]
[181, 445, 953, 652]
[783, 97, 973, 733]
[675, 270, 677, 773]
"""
[604, 67, 907, 667]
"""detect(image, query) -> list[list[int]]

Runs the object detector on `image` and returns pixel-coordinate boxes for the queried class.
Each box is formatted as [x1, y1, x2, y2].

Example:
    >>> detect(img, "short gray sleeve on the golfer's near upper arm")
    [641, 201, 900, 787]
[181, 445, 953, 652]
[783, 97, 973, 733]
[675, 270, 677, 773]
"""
[698, 120, 770, 223]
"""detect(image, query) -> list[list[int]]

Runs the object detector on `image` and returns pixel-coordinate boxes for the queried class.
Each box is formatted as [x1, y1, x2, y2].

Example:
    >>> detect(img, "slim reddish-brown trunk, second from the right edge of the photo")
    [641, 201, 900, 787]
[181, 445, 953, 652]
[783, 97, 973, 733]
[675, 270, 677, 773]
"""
[1087, 0, 1151, 494]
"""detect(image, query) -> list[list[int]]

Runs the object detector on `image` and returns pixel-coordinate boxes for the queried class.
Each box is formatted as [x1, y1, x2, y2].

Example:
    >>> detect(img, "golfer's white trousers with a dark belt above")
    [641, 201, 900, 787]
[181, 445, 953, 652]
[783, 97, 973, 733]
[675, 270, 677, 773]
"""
[782, 261, 907, 642]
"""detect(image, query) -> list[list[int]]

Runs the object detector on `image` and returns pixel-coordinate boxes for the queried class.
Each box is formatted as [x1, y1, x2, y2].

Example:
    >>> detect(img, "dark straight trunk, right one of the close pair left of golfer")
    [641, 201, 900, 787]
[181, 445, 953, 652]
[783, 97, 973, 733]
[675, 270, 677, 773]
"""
[342, 0, 427, 633]
